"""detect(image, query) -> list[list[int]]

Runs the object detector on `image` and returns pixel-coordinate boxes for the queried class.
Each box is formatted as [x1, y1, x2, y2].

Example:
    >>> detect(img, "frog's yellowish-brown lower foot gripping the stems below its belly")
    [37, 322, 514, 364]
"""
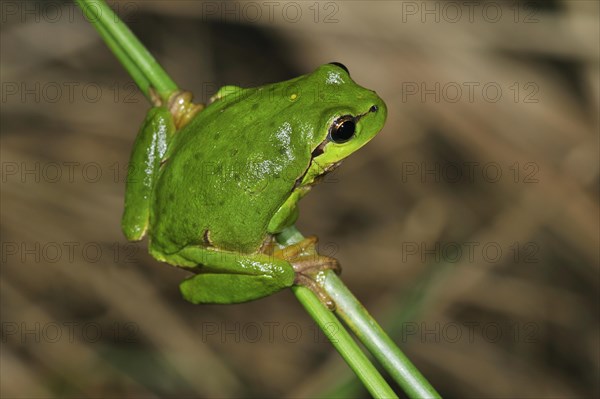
[272, 237, 342, 310]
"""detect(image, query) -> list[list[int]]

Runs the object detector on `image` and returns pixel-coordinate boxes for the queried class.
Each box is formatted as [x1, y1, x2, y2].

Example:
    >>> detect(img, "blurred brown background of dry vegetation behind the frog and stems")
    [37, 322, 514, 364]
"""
[0, 1, 600, 398]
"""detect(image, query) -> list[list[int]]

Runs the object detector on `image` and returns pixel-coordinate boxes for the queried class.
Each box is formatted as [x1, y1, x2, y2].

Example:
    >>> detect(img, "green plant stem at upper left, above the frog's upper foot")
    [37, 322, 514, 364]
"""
[76, 0, 178, 103]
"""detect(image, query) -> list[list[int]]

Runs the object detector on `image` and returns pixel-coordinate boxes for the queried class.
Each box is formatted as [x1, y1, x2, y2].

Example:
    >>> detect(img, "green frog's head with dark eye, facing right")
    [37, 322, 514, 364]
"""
[296, 62, 387, 186]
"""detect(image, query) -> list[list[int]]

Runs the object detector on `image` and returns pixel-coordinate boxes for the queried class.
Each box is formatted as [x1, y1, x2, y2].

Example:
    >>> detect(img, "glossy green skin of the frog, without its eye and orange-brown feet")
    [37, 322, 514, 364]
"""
[122, 64, 386, 303]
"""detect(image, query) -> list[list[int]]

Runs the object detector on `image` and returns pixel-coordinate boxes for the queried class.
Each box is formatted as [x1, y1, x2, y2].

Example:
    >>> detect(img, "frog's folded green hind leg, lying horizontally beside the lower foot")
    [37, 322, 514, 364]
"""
[165, 246, 295, 304]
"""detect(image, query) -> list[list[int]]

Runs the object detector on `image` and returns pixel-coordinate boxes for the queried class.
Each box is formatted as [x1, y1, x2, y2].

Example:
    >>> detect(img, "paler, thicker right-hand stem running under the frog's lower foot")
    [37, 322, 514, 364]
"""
[278, 227, 441, 398]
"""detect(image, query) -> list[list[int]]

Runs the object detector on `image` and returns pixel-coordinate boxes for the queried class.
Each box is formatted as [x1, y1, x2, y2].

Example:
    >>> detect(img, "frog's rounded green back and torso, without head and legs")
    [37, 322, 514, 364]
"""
[149, 88, 311, 253]
